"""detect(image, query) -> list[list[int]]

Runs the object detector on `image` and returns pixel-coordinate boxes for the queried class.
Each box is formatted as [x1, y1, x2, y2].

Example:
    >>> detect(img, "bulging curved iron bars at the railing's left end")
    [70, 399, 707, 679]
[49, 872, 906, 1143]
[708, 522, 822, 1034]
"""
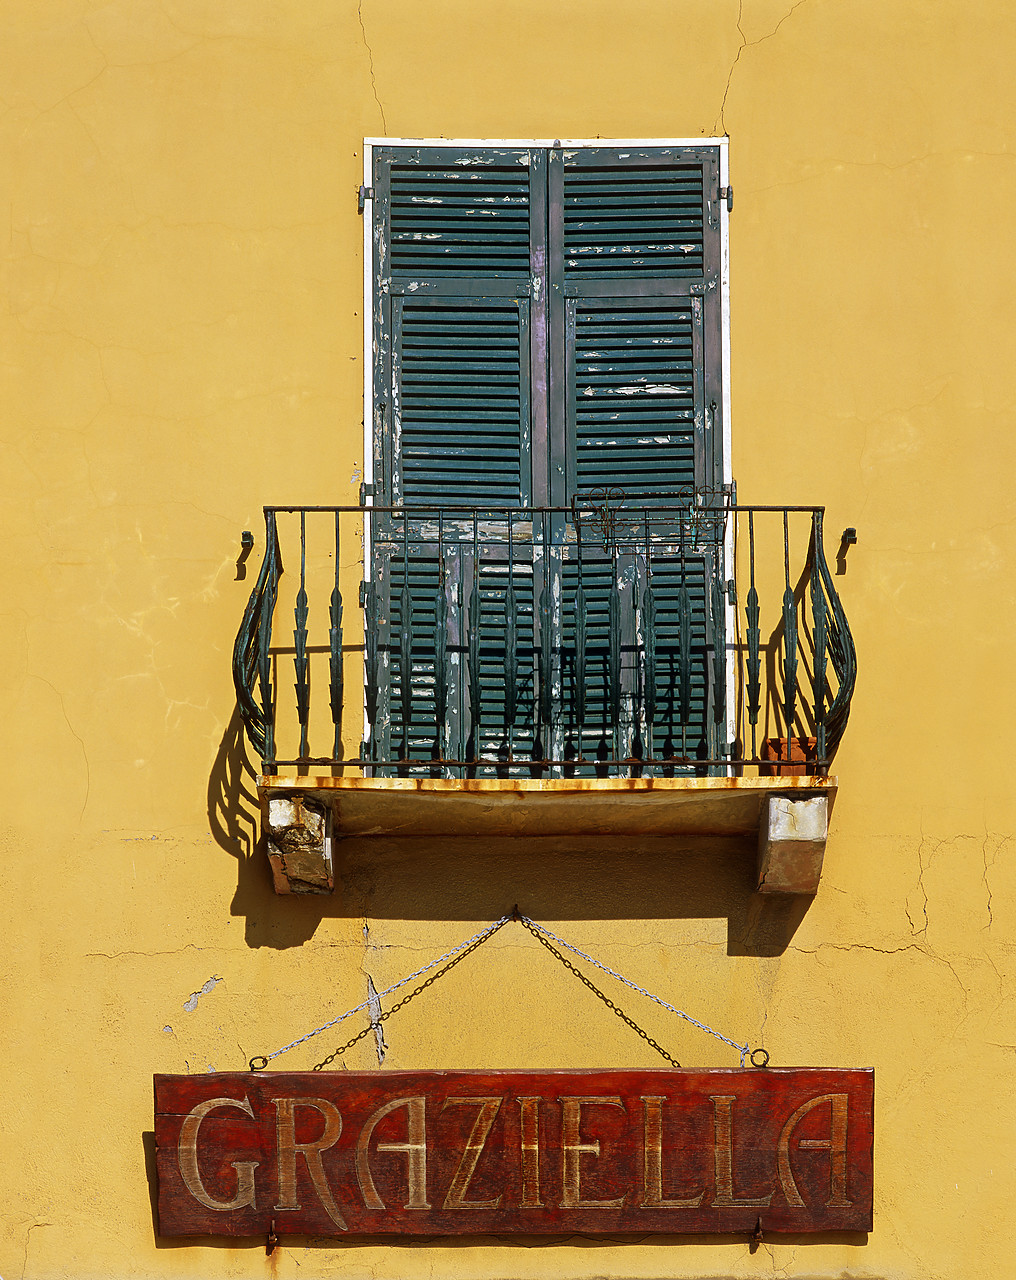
[233, 511, 283, 762]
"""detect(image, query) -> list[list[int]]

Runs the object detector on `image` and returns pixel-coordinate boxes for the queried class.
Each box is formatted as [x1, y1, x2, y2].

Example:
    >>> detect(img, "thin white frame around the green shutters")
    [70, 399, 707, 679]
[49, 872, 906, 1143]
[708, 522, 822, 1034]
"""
[362, 137, 737, 768]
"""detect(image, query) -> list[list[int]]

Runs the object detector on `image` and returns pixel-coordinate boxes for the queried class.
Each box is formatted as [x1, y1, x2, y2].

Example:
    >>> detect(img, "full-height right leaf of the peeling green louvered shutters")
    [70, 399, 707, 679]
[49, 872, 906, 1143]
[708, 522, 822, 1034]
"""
[548, 147, 726, 773]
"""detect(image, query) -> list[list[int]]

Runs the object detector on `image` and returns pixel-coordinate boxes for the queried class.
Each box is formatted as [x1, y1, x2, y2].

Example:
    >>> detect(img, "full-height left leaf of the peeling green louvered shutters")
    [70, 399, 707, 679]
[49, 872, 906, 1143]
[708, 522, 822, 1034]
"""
[374, 147, 546, 774]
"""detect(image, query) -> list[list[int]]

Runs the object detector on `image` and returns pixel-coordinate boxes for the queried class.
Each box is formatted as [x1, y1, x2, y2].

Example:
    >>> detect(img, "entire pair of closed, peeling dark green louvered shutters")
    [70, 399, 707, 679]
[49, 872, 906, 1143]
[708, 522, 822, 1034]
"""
[374, 147, 724, 773]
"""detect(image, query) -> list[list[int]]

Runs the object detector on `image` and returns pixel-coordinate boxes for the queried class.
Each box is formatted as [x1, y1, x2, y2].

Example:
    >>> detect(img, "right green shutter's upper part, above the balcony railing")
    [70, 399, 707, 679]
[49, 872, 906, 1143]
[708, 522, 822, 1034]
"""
[549, 147, 722, 504]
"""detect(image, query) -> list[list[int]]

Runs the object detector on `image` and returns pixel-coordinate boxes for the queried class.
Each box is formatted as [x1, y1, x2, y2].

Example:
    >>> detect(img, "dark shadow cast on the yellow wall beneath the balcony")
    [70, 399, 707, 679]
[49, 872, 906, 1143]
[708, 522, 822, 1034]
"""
[209, 710, 811, 956]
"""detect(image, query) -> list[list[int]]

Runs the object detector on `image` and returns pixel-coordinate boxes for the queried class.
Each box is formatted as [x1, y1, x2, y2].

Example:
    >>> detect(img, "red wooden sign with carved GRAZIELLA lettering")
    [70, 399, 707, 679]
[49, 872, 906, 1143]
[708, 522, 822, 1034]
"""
[155, 1069, 874, 1236]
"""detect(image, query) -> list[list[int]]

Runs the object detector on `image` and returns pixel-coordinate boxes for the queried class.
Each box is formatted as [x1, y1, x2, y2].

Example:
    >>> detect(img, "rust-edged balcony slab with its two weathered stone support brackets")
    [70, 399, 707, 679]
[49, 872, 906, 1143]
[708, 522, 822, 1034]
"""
[258, 773, 837, 893]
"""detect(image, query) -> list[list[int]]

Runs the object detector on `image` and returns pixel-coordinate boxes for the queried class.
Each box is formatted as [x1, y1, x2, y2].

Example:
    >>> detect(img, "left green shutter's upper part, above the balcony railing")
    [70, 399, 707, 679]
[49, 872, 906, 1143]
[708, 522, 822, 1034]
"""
[374, 147, 545, 507]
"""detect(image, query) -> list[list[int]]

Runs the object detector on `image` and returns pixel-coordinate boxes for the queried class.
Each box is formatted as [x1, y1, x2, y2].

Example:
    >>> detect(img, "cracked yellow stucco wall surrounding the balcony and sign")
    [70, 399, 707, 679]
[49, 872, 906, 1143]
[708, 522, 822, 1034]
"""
[0, 0, 1016, 1280]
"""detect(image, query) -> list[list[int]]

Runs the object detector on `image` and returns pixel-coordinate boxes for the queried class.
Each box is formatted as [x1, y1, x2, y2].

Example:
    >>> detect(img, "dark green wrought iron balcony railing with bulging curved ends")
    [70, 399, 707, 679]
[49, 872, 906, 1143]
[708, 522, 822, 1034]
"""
[233, 490, 856, 777]
